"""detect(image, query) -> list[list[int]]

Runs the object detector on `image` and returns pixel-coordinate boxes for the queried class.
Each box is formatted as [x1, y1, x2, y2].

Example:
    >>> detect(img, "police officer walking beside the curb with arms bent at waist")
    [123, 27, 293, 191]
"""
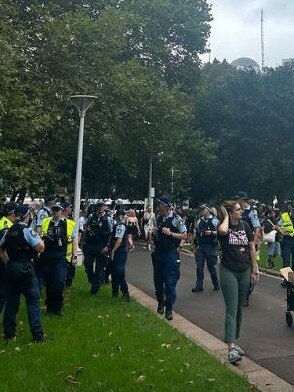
[152, 196, 187, 320]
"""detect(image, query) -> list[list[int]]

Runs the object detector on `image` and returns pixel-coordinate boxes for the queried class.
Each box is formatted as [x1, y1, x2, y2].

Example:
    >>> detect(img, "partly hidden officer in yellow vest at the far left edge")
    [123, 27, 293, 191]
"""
[0, 202, 17, 314]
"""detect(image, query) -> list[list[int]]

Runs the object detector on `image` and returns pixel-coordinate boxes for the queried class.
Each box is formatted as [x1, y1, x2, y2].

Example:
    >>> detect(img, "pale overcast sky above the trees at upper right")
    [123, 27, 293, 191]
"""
[203, 0, 294, 67]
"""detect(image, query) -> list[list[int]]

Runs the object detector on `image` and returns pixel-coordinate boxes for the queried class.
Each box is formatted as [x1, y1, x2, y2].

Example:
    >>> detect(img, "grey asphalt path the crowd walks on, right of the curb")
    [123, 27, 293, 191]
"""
[127, 244, 294, 385]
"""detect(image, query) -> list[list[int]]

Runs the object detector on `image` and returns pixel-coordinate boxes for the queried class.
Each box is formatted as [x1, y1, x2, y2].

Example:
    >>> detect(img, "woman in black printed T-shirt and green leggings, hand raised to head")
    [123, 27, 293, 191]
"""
[218, 201, 259, 364]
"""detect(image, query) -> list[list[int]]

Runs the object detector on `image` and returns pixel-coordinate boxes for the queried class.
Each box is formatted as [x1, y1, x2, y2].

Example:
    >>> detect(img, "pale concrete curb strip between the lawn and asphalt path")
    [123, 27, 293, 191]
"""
[129, 284, 294, 392]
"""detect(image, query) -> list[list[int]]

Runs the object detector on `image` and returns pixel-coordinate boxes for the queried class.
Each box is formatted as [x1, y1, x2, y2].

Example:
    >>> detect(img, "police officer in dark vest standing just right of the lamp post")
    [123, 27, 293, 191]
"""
[84, 200, 113, 295]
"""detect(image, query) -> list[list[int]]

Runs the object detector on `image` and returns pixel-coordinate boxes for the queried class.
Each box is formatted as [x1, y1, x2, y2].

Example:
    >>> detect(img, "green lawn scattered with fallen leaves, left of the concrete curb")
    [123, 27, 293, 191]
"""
[0, 268, 256, 392]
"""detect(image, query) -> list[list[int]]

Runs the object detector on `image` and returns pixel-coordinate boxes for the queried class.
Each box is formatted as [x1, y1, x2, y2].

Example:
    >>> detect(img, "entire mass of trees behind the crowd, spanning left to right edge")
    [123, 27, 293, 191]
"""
[0, 0, 294, 202]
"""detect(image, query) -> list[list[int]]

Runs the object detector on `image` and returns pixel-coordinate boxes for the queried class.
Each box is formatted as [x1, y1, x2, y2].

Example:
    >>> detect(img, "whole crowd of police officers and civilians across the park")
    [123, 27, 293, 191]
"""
[0, 192, 294, 363]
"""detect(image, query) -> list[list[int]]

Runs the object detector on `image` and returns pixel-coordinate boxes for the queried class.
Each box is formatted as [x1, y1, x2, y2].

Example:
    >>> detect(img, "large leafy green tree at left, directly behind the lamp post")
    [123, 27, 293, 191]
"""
[0, 0, 211, 202]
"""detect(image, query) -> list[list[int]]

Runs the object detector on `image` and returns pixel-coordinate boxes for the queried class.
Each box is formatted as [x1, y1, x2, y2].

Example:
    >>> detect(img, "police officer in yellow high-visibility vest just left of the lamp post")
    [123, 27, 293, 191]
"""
[40, 203, 77, 316]
